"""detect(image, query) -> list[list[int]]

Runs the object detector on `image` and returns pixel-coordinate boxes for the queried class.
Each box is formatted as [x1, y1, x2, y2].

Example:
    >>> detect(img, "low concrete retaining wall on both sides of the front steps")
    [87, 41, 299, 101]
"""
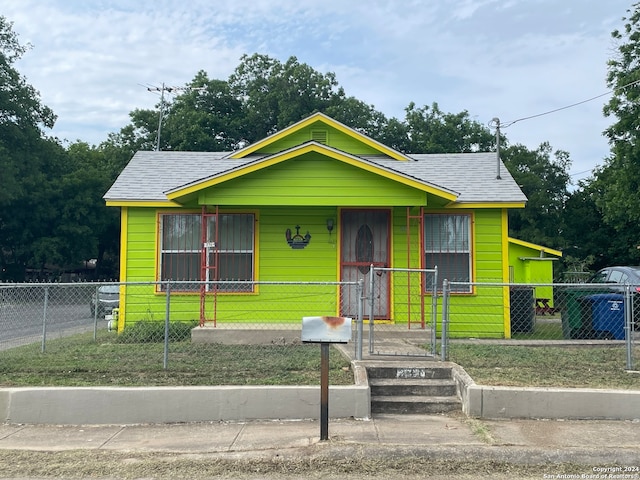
[0, 361, 640, 425]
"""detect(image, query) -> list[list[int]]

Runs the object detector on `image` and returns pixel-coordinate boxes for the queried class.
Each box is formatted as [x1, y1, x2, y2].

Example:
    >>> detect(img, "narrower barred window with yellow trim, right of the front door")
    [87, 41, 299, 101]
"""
[424, 214, 471, 293]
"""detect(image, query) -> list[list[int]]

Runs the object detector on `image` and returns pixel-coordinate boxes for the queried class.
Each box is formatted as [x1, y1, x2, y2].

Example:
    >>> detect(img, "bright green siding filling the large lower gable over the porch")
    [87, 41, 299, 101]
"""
[199, 153, 426, 207]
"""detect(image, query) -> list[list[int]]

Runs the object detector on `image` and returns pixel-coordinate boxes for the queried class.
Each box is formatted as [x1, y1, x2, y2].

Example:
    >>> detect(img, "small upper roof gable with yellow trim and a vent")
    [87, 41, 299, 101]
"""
[230, 113, 409, 161]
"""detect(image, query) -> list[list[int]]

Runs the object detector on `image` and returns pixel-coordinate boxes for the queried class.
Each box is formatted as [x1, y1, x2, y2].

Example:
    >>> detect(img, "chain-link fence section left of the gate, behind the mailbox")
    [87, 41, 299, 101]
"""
[0, 282, 362, 386]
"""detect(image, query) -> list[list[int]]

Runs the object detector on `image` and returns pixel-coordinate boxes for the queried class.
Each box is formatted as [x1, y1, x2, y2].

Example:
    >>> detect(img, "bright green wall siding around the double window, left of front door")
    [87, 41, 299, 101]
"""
[122, 207, 338, 324]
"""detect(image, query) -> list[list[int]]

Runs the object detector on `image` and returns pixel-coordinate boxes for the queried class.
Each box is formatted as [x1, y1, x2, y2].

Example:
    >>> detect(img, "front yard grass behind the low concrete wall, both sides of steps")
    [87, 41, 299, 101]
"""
[0, 326, 640, 390]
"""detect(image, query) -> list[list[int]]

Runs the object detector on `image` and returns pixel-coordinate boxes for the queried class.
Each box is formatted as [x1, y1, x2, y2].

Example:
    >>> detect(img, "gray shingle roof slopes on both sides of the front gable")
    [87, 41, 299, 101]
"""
[104, 151, 526, 203]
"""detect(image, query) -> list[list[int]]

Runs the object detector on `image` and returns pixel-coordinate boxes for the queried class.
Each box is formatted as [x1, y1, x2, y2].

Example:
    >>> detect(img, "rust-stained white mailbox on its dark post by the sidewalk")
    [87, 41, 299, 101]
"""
[302, 317, 351, 440]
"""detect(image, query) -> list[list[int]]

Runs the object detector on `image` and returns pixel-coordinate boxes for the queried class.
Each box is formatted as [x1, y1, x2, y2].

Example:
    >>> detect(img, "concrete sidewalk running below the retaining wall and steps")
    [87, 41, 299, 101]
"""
[0, 414, 640, 465]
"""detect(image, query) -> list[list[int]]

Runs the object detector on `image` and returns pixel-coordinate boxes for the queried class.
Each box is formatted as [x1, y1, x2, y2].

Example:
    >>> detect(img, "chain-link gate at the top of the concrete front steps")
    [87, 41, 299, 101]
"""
[364, 265, 438, 357]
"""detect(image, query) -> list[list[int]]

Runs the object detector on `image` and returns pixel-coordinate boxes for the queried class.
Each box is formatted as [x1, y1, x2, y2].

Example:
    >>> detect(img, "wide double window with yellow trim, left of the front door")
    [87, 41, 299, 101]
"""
[159, 214, 254, 292]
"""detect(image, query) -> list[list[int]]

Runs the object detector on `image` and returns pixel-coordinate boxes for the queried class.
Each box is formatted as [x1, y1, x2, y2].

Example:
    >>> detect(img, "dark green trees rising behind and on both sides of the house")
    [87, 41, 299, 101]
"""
[0, 12, 592, 280]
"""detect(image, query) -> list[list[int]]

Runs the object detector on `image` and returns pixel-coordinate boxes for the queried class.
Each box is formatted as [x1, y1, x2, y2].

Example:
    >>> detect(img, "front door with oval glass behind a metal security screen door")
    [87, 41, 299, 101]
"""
[340, 210, 391, 319]
